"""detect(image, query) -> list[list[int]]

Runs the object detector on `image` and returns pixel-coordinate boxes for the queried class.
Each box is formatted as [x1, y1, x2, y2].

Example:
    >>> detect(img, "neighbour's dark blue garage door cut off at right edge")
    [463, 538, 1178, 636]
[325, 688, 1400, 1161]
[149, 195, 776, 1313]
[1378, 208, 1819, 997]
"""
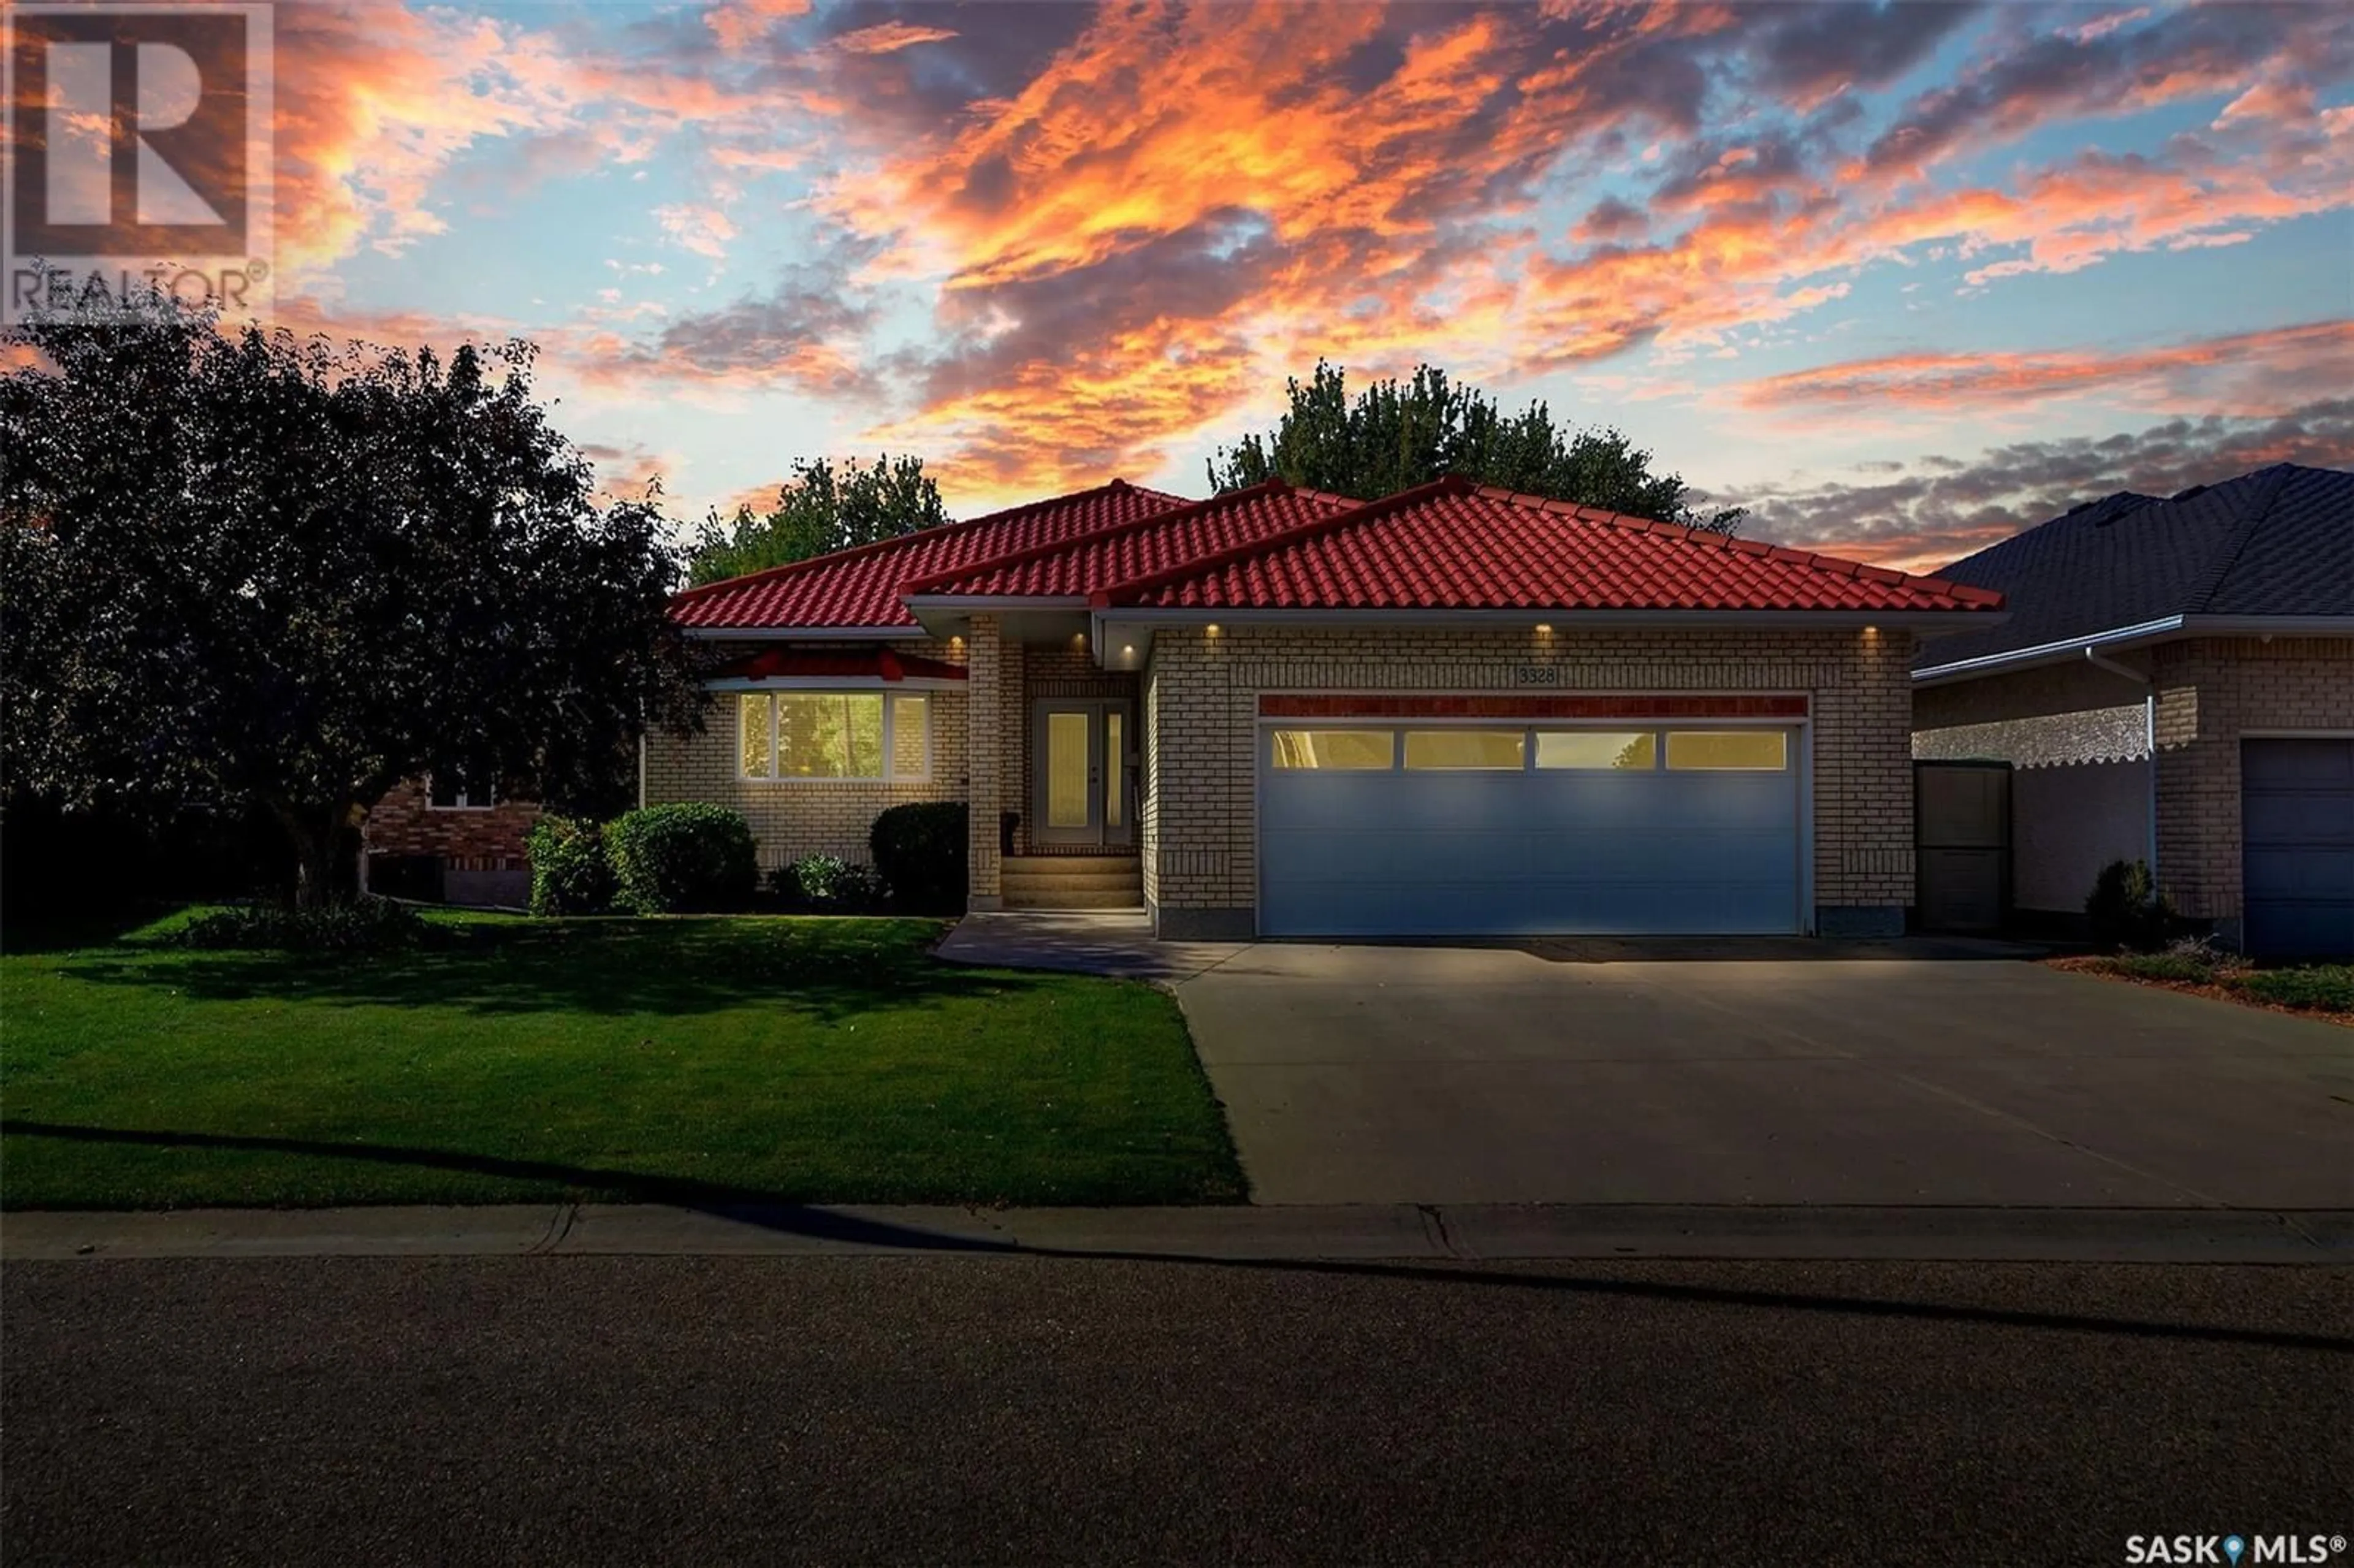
[2239, 739, 2354, 958]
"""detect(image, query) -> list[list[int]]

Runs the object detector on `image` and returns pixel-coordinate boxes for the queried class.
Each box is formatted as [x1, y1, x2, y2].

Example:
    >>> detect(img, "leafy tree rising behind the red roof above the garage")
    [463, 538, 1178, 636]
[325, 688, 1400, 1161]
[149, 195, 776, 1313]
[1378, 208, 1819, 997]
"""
[1210, 360, 1746, 535]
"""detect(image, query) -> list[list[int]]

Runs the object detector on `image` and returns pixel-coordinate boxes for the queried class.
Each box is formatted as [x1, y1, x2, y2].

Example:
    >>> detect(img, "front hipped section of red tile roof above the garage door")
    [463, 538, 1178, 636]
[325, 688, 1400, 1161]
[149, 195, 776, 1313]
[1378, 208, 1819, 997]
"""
[1092, 478, 2003, 612]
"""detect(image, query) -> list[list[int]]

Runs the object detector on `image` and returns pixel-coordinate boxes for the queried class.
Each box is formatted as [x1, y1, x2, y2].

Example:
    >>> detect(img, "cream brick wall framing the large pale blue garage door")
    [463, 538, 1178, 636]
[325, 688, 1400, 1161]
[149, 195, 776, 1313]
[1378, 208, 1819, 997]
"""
[1144, 626, 1914, 932]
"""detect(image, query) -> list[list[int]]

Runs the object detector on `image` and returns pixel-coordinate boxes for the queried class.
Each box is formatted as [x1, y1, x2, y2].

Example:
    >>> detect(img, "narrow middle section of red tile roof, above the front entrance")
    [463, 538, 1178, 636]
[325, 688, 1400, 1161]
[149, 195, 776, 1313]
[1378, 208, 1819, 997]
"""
[906, 481, 1361, 598]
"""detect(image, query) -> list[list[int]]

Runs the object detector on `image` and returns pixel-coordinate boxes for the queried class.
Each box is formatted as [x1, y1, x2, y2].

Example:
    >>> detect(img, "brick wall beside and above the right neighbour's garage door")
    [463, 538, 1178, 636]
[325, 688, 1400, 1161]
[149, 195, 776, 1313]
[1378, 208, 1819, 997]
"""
[2152, 638, 2354, 939]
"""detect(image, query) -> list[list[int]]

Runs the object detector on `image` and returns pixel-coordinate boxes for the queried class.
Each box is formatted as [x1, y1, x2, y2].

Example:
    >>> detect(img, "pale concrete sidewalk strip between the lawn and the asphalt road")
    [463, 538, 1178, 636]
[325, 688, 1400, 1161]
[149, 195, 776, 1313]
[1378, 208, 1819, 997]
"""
[0, 1203, 2354, 1265]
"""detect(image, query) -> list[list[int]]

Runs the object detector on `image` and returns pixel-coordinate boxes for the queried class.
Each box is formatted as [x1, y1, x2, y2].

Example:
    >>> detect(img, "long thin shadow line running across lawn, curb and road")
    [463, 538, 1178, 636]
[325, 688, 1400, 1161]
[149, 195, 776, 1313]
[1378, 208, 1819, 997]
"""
[0, 1118, 2354, 1353]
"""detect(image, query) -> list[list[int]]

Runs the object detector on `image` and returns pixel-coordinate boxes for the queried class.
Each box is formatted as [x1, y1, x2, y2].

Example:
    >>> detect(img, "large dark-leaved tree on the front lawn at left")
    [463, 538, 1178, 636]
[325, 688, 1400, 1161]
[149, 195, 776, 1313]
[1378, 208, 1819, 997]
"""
[0, 308, 701, 907]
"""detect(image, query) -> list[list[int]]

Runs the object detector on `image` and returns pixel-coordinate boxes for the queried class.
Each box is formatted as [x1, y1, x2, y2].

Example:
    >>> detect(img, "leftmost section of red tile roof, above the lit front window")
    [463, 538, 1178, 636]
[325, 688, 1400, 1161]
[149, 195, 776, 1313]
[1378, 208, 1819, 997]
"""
[671, 481, 1189, 631]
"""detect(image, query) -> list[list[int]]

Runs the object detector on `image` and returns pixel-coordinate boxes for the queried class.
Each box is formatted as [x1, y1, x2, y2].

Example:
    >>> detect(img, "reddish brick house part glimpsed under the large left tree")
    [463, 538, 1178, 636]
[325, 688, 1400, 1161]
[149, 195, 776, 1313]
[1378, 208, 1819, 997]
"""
[360, 775, 539, 909]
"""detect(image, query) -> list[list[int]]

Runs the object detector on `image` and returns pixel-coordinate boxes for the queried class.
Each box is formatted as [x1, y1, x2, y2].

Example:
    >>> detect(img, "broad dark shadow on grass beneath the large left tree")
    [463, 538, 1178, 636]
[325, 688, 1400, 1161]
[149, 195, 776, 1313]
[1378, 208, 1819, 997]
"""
[61, 918, 1068, 1024]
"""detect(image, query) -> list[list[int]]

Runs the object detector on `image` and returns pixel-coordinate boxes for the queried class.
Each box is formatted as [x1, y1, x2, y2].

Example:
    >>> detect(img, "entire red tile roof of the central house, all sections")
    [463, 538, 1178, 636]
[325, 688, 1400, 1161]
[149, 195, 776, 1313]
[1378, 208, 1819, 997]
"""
[671, 478, 2003, 631]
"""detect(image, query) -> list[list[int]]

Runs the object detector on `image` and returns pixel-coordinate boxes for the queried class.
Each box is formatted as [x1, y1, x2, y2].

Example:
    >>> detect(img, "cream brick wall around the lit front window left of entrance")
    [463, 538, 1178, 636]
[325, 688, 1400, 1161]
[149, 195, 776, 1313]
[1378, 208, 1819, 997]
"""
[645, 638, 967, 873]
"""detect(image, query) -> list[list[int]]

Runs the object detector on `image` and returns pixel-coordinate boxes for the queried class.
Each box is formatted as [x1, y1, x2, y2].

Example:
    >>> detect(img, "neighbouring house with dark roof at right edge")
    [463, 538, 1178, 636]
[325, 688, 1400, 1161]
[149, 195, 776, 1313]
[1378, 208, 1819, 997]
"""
[1914, 464, 2354, 956]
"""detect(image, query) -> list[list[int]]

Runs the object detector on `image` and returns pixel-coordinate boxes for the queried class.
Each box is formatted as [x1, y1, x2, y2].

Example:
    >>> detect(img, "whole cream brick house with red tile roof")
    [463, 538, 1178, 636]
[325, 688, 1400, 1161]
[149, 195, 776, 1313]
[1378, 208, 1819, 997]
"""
[640, 478, 2001, 937]
